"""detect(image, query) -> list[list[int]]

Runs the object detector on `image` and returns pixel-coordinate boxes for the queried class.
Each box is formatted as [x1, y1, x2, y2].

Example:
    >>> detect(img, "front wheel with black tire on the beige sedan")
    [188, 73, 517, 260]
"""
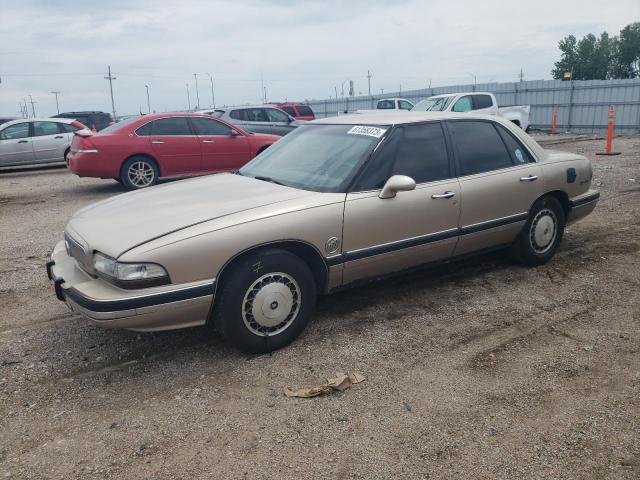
[214, 248, 316, 353]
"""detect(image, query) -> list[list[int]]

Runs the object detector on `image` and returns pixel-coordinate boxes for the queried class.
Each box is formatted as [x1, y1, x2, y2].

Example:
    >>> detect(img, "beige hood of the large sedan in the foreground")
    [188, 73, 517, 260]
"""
[66, 174, 317, 258]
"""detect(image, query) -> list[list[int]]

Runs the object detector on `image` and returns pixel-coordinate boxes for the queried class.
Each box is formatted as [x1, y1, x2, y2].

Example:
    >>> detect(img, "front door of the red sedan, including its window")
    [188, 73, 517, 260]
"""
[190, 117, 251, 172]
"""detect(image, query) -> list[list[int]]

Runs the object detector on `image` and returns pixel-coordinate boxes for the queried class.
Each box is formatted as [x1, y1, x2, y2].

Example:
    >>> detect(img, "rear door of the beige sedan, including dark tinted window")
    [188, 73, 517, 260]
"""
[447, 120, 544, 255]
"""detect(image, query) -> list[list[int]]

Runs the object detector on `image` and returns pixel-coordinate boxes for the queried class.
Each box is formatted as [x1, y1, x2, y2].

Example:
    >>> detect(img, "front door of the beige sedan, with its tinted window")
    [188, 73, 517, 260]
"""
[341, 122, 460, 283]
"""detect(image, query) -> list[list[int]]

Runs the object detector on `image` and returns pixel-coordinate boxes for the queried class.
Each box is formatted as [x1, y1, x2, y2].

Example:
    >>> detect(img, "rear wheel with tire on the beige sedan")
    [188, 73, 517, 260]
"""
[511, 196, 565, 266]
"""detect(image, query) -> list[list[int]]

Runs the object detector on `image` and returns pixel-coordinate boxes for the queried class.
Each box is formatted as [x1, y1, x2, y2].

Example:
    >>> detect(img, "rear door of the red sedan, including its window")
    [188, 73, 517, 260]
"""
[149, 117, 202, 176]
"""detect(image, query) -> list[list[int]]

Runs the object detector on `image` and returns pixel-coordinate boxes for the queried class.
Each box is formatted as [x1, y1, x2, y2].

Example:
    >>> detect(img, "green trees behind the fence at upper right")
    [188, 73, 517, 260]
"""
[551, 22, 640, 80]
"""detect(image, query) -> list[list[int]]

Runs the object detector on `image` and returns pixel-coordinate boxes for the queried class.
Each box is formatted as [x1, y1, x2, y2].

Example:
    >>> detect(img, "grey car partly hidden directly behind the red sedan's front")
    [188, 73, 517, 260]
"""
[212, 105, 303, 136]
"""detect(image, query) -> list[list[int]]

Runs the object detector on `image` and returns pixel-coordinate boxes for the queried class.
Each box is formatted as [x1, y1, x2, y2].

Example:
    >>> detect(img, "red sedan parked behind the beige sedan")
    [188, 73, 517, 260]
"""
[68, 113, 280, 189]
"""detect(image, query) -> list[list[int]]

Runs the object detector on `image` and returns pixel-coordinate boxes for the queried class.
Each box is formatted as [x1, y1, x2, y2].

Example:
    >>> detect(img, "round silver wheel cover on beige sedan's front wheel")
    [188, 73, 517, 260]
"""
[242, 272, 302, 337]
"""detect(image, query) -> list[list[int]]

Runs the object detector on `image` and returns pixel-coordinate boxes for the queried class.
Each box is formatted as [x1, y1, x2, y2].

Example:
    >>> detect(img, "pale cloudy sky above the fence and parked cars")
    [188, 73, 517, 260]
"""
[0, 0, 640, 117]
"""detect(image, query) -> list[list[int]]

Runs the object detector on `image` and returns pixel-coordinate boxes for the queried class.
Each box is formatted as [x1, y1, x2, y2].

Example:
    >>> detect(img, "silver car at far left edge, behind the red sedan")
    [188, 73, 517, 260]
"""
[0, 118, 86, 167]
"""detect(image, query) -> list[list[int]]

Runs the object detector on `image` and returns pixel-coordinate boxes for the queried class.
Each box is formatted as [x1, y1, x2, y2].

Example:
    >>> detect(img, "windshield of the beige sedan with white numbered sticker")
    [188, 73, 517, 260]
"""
[239, 125, 389, 192]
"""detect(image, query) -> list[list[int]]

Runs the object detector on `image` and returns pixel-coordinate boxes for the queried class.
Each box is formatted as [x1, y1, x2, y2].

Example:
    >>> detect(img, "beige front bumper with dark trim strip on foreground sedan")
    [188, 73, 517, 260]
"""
[47, 242, 215, 331]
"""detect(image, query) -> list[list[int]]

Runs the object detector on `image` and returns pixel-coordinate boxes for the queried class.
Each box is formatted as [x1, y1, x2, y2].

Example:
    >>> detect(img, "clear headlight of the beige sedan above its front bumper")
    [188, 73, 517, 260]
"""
[93, 252, 170, 288]
